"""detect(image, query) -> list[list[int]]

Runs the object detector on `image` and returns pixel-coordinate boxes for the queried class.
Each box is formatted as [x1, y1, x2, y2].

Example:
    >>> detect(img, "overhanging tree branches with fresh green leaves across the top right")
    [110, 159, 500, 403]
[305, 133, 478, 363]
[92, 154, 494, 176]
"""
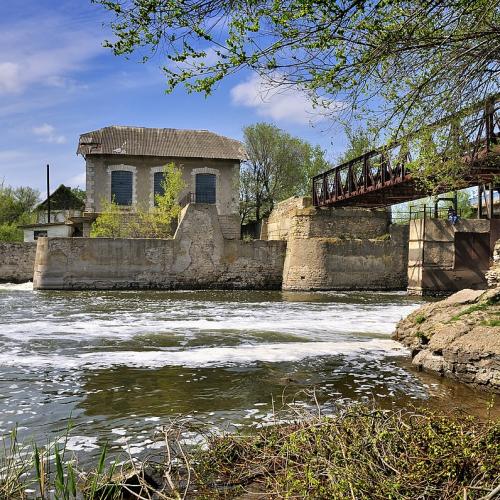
[93, 0, 500, 136]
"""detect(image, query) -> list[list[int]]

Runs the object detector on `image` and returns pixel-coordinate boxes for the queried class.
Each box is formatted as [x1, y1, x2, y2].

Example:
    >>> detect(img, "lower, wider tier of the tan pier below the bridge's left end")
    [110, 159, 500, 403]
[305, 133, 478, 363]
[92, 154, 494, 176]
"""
[283, 226, 408, 290]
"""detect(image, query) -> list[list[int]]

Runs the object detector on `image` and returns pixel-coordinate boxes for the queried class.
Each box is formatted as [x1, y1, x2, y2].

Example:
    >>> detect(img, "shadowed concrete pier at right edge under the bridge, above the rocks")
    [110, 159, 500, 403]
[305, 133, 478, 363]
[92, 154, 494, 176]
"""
[408, 219, 500, 295]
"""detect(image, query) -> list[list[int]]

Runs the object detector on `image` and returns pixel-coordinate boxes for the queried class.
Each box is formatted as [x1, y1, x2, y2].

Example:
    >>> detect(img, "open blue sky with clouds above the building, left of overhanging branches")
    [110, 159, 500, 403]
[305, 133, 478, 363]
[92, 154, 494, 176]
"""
[0, 0, 352, 192]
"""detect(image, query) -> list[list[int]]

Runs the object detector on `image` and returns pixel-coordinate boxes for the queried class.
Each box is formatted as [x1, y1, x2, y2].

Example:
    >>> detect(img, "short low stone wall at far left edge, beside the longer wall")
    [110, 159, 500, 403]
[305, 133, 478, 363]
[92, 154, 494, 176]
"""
[0, 243, 36, 283]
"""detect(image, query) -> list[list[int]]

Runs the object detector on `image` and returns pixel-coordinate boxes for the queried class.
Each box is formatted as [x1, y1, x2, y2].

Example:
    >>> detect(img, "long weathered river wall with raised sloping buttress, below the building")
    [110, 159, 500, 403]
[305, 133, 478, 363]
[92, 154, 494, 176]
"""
[34, 204, 286, 289]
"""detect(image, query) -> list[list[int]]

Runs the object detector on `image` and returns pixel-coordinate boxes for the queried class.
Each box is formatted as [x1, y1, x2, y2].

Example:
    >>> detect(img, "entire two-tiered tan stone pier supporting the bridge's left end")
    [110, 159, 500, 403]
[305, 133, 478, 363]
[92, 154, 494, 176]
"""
[265, 198, 408, 290]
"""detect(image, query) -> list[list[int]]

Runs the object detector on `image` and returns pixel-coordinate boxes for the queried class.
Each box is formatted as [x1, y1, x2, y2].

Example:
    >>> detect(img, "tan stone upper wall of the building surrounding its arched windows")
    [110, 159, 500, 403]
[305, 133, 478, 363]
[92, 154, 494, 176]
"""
[86, 154, 240, 215]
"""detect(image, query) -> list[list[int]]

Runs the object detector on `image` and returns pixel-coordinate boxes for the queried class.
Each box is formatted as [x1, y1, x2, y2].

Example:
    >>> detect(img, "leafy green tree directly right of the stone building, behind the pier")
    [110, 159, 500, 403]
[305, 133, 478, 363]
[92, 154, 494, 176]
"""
[240, 123, 328, 222]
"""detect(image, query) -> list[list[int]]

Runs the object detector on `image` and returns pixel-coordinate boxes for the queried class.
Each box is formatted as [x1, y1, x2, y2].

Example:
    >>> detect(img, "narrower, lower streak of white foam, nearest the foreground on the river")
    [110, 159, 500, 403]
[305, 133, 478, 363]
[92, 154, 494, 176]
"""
[0, 339, 408, 369]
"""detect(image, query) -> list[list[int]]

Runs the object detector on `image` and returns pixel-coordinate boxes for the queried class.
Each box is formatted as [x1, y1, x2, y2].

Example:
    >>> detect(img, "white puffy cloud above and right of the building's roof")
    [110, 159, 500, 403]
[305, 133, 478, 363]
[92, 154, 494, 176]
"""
[231, 74, 339, 125]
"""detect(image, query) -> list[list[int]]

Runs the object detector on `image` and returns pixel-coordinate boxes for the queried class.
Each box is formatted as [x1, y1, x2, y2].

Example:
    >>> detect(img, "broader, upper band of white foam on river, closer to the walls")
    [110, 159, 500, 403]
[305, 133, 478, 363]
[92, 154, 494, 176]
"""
[0, 303, 417, 343]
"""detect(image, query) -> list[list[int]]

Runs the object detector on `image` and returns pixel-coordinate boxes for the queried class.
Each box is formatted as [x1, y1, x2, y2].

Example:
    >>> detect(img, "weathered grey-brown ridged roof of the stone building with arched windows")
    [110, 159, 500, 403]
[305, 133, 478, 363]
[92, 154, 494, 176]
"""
[77, 126, 245, 160]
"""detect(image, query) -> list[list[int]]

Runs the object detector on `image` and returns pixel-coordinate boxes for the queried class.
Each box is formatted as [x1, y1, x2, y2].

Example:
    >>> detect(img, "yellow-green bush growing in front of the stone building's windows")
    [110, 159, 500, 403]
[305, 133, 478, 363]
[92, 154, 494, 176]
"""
[90, 163, 185, 238]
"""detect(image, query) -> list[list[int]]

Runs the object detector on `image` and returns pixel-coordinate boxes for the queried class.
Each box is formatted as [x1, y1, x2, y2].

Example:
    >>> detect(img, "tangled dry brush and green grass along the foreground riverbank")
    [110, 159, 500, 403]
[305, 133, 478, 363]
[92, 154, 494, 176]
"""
[0, 404, 500, 500]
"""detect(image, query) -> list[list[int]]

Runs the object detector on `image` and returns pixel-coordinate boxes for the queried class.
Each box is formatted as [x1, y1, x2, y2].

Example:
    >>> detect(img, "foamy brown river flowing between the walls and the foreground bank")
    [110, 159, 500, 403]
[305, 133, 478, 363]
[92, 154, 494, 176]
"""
[0, 284, 494, 462]
